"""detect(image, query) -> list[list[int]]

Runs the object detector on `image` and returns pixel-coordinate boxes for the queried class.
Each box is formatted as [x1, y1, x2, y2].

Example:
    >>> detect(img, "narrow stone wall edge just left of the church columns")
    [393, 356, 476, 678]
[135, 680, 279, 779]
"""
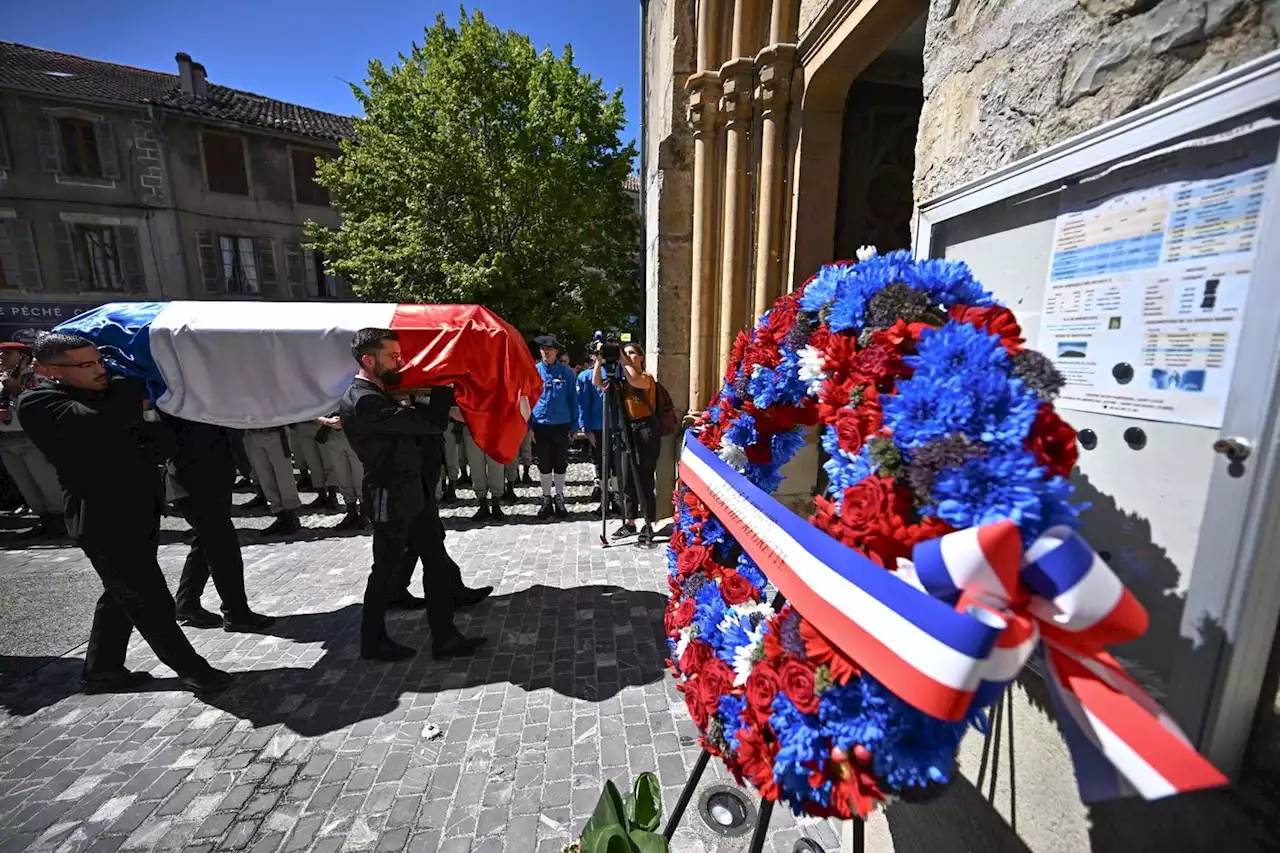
[641, 0, 696, 516]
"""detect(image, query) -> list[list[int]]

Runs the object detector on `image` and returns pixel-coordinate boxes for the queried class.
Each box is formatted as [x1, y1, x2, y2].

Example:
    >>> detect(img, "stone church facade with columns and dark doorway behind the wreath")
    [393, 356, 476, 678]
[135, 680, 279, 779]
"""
[641, 0, 1280, 853]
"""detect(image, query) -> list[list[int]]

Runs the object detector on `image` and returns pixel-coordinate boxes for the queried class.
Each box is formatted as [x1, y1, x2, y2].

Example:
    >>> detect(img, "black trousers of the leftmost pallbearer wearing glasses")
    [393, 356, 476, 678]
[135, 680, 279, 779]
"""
[75, 507, 209, 678]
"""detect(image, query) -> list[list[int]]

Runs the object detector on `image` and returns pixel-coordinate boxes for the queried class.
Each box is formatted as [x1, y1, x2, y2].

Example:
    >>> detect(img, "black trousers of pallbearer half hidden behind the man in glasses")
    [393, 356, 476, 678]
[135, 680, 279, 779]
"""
[174, 494, 250, 616]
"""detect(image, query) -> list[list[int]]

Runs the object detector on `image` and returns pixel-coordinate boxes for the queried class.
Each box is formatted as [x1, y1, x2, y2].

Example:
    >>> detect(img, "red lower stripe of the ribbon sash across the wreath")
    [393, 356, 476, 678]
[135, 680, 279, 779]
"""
[680, 462, 973, 721]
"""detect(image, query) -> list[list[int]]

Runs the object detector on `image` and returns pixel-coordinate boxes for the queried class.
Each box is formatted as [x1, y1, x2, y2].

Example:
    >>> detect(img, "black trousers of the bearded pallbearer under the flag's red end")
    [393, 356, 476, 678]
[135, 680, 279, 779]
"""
[360, 514, 458, 646]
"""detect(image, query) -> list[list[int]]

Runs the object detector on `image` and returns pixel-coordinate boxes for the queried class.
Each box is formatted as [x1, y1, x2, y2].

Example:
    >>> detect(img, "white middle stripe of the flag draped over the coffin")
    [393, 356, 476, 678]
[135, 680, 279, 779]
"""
[150, 302, 397, 429]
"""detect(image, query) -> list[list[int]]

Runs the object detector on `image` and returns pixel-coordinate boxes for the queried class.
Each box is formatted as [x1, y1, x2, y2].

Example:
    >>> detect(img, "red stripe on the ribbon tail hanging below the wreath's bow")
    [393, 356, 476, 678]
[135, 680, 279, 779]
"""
[1047, 647, 1228, 793]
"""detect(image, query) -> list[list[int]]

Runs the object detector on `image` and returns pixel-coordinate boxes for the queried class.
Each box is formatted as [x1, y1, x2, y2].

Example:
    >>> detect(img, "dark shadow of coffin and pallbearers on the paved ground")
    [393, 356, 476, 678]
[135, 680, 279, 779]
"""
[0, 585, 666, 736]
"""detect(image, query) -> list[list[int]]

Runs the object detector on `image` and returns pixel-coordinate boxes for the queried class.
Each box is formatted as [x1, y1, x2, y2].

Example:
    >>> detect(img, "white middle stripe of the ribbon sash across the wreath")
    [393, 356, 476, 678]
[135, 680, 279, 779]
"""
[680, 452, 982, 692]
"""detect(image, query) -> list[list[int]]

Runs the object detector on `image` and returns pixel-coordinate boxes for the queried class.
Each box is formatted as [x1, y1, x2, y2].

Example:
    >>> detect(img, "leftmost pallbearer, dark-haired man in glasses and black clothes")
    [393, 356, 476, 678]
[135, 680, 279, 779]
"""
[19, 332, 232, 693]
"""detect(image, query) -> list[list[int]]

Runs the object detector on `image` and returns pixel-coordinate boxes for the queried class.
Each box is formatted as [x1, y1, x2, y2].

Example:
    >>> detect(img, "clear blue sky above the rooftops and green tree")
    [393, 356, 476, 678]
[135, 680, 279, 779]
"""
[0, 0, 640, 148]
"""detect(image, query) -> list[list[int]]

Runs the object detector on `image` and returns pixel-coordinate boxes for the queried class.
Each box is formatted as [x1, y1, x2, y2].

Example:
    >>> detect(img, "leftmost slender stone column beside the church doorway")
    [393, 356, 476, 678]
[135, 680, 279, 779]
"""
[686, 69, 721, 416]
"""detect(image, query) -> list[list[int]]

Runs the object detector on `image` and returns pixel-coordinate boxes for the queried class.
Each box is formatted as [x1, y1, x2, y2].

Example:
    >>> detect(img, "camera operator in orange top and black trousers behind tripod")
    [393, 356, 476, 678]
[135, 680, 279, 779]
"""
[591, 342, 662, 544]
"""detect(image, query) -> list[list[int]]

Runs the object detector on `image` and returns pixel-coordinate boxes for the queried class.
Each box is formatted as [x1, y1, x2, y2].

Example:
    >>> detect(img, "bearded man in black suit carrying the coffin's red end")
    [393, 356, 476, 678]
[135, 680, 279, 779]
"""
[339, 329, 485, 661]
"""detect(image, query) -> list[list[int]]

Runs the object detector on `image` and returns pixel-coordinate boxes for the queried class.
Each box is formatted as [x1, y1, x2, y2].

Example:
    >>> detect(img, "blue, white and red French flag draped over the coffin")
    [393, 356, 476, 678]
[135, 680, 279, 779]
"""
[58, 302, 541, 464]
